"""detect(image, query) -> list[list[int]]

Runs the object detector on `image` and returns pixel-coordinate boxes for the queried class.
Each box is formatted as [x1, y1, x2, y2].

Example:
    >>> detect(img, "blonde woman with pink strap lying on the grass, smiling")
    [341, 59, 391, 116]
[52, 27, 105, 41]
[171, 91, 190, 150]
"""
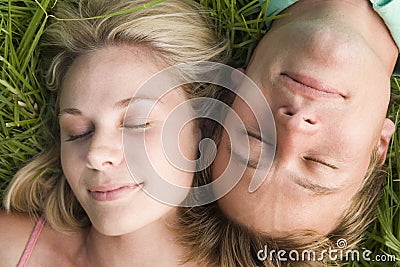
[0, 0, 227, 266]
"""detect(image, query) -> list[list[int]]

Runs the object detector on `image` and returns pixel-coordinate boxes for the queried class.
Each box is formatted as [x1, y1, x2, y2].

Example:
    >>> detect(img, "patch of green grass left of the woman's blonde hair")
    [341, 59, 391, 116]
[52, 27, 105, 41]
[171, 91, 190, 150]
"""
[0, 0, 54, 198]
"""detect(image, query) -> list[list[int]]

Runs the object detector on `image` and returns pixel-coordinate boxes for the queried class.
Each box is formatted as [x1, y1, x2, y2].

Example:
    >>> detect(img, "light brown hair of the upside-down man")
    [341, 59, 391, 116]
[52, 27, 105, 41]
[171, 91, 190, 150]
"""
[175, 121, 385, 267]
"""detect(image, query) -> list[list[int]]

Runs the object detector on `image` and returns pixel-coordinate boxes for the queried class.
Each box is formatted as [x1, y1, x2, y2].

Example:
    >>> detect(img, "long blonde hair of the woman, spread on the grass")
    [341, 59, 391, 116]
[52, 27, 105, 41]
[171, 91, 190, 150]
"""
[3, 0, 229, 232]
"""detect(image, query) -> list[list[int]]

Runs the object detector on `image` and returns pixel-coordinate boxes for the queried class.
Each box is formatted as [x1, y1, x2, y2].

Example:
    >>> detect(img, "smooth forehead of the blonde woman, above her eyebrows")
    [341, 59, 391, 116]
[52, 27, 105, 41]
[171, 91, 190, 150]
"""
[60, 47, 163, 109]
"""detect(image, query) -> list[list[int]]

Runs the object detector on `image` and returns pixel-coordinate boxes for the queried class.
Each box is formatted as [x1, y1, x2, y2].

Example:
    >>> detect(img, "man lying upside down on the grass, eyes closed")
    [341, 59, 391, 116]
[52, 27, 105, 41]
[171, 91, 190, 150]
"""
[181, 0, 400, 266]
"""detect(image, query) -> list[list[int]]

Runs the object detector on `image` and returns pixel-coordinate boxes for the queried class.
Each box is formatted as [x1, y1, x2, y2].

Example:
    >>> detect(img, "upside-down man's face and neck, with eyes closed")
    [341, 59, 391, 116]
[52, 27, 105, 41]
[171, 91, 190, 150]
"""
[212, 0, 398, 236]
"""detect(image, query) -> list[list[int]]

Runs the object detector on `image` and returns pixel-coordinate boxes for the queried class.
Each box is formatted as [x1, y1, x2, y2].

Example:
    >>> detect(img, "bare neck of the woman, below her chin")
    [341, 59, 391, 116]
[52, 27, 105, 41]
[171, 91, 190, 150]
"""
[82, 209, 190, 266]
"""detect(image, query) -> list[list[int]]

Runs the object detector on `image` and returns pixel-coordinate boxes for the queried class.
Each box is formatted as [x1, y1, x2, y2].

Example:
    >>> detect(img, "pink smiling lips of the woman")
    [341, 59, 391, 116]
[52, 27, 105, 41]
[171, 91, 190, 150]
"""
[88, 184, 141, 201]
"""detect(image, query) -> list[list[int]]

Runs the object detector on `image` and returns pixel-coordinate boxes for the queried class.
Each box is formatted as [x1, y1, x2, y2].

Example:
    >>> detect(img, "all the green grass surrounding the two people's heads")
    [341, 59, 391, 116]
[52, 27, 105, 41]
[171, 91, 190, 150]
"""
[0, 0, 400, 266]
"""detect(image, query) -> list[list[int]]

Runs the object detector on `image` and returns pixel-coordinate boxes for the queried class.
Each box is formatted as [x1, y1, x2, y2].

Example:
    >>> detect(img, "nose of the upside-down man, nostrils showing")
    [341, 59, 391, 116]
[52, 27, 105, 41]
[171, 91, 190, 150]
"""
[275, 107, 320, 136]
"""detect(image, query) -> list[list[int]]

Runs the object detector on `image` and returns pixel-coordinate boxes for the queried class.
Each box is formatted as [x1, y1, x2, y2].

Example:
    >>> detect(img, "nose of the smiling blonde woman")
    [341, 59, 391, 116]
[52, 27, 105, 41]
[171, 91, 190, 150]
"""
[86, 131, 124, 171]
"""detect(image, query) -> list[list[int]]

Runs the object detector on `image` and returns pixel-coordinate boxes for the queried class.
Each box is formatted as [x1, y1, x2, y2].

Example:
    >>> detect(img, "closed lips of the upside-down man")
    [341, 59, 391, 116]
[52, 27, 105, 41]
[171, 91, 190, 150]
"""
[281, 72, 345, 98]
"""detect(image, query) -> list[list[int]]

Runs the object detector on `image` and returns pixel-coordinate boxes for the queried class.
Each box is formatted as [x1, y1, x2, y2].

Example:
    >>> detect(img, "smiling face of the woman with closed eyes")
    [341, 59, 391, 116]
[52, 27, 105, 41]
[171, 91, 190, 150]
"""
[59, 47, 197, 235]
